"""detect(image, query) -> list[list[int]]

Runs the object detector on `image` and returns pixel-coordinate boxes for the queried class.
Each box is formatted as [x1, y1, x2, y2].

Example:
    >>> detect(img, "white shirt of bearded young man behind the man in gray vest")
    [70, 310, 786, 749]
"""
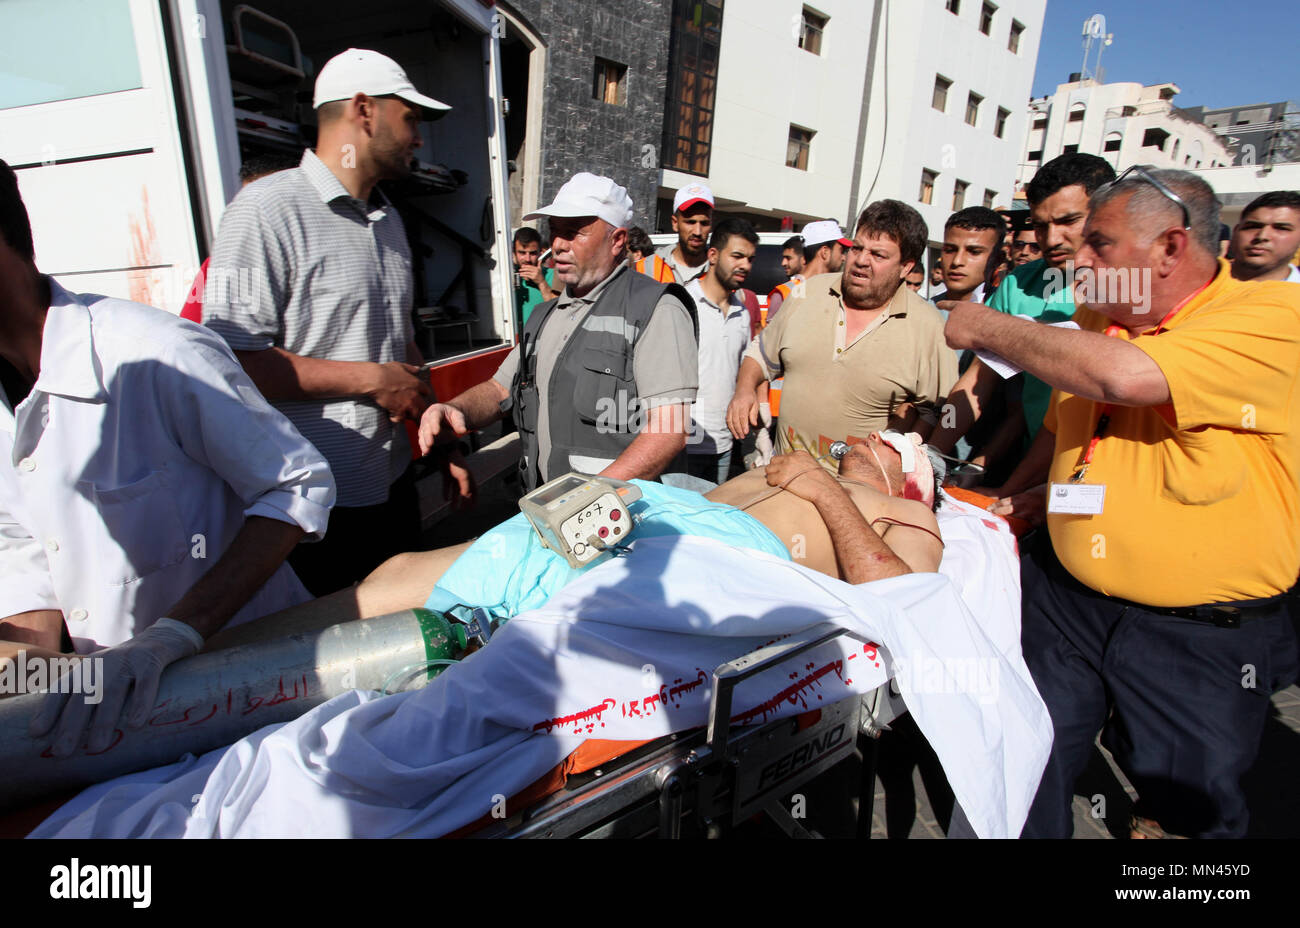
[686, 278, 749, 455]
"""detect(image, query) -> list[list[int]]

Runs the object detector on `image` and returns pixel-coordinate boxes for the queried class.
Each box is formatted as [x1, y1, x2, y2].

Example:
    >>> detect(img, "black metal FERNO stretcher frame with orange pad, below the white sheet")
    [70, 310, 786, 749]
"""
[462, 624, 906, 838]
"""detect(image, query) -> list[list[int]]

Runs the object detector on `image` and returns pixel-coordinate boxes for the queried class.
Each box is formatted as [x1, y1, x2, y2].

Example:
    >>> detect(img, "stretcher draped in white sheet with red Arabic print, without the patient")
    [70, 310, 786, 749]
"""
[25, 513, 1050, 837]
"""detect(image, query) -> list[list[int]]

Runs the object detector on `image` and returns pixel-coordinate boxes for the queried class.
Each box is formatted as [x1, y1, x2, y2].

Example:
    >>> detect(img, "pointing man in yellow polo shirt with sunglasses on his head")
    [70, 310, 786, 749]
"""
[946, 168, 1300, 837]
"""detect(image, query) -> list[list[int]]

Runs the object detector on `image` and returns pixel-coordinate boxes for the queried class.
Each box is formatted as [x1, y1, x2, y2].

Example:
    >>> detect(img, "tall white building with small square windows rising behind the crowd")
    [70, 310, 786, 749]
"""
[659, 0, 1045, 256]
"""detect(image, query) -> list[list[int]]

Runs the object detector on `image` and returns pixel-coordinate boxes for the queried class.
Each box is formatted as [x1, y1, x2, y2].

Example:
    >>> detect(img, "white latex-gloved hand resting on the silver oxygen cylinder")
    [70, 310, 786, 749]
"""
[29, 619, 203, 758]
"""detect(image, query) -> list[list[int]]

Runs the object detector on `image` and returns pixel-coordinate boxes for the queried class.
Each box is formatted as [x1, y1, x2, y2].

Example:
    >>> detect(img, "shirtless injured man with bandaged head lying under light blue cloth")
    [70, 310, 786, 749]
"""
[205, 432, 944, 651]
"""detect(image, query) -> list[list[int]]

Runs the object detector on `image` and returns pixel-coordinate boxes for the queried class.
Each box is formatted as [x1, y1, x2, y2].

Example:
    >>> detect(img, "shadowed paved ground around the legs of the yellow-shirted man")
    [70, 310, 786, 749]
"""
[871, 686, 1300, 838]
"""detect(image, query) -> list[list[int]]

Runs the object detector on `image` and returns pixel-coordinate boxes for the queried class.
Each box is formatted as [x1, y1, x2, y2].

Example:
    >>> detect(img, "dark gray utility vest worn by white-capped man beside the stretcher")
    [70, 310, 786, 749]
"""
[510, 268, 699, 491]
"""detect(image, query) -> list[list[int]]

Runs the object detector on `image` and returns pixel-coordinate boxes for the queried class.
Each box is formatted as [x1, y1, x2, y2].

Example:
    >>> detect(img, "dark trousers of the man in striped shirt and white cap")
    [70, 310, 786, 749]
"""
[289, 468, 420, 597]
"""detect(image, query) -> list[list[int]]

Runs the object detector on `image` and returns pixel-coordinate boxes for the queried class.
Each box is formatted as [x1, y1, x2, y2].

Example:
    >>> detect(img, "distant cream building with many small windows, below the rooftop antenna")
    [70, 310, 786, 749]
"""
[1017, 79, 1234, 188]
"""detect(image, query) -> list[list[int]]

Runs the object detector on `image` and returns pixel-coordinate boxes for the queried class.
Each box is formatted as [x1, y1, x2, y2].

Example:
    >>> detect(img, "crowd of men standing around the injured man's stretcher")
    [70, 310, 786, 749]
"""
[0, 49, 1300, 837]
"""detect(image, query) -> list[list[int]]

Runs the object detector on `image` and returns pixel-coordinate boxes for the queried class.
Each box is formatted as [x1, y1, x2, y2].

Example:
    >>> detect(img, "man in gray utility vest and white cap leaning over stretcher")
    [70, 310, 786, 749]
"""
[420, 173, 698, 490]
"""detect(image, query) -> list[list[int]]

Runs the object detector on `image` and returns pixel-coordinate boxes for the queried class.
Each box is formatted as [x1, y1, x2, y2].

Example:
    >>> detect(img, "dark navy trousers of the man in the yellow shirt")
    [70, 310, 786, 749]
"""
[1021, 537, 1296, 838]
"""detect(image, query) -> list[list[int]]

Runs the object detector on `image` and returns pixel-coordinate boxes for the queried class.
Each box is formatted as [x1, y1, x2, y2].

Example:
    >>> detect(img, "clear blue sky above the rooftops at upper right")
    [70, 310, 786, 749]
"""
[1034, 0, 1300, 108]
